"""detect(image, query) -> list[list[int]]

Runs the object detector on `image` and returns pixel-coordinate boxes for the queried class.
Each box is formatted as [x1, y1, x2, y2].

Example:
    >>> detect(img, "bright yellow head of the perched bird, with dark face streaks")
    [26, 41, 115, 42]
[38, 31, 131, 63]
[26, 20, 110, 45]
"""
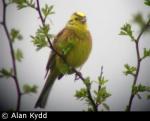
[67, 12, 88, 30]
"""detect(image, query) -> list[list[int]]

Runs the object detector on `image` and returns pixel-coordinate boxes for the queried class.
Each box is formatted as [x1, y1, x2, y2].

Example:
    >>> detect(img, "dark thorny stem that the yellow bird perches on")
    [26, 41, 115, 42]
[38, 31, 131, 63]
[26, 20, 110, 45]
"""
[36, 0, 98, 112]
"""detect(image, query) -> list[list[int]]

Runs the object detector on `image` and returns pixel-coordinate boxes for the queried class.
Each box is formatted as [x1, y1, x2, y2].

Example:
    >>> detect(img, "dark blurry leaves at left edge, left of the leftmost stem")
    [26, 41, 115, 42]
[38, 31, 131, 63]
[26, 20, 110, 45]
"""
[0, 68, 13, 78]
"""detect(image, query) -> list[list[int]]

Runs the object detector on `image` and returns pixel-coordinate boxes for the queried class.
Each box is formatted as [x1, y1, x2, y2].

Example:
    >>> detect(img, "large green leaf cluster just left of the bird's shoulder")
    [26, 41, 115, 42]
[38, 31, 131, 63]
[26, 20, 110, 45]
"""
[31, 24, 53, 50]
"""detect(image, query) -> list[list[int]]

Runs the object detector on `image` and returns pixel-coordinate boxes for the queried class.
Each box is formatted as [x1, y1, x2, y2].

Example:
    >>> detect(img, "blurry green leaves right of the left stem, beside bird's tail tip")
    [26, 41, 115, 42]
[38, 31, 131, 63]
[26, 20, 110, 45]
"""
[23, 84, 37, 94]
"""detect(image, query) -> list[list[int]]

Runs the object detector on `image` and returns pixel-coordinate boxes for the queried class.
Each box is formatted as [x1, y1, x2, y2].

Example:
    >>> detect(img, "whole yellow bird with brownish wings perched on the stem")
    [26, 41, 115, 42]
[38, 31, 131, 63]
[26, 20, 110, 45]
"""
[35, 12, 92, 108]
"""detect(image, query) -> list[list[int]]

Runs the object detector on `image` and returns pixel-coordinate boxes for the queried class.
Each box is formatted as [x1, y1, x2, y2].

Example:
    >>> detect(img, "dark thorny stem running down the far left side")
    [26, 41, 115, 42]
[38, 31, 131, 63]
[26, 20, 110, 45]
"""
[1, 0, 21, 111]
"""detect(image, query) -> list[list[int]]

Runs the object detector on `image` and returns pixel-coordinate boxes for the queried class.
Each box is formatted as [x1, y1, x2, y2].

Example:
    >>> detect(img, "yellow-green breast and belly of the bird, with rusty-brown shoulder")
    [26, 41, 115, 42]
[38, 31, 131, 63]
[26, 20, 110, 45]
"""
[54, 27, 92, 73]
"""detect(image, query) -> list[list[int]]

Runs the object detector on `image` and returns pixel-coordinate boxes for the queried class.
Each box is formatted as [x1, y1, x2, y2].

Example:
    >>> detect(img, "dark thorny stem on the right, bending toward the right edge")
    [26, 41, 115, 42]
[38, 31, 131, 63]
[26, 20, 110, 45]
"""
[127, 19, 150, 111]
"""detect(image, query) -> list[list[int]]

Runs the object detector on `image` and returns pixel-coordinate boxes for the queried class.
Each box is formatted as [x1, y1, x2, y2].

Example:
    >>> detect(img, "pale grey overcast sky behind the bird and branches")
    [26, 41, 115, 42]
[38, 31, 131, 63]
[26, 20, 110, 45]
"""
[0, 0, 150, 111]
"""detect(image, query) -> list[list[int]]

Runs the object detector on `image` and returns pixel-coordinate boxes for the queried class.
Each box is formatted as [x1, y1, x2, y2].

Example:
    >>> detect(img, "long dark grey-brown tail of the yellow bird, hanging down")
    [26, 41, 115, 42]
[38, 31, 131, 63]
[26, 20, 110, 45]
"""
[35, 69, 57, 108]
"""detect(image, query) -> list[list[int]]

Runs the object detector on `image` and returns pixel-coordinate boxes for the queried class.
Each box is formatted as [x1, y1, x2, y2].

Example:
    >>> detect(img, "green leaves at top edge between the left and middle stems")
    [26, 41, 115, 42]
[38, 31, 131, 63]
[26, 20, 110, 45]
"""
[9, 0, 35, 9]
